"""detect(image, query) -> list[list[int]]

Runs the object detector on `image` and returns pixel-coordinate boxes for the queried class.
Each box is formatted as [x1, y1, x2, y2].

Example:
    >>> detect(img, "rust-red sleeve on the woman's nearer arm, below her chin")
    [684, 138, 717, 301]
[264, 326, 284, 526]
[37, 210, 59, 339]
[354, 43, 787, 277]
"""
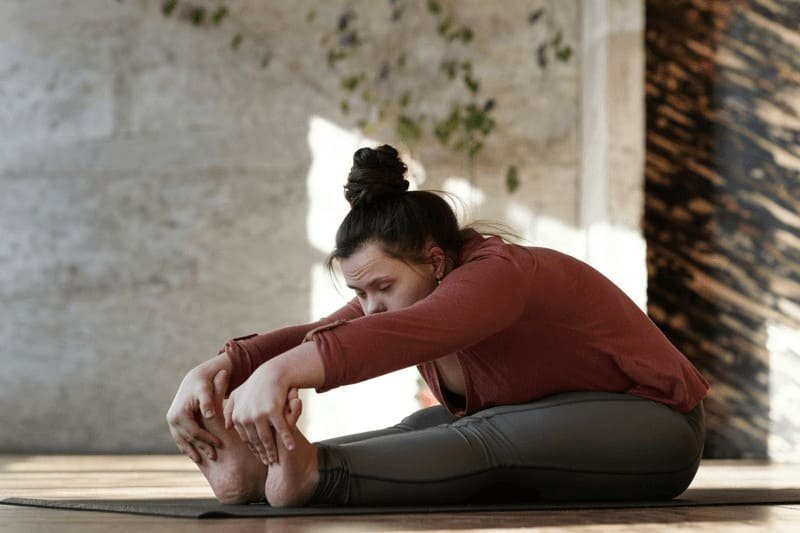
[310, 245, 529, 392]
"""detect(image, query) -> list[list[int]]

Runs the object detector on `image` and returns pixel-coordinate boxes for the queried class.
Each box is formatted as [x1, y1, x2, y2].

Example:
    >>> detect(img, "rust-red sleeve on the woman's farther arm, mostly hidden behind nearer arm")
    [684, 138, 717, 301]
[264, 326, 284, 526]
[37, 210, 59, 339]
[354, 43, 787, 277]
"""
[217, 298, 364, 392]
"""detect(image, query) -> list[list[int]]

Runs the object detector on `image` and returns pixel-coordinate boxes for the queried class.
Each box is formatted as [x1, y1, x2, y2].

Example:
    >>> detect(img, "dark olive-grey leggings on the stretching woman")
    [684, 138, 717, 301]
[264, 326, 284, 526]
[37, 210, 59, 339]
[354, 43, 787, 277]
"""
[309, 392, 705, 505]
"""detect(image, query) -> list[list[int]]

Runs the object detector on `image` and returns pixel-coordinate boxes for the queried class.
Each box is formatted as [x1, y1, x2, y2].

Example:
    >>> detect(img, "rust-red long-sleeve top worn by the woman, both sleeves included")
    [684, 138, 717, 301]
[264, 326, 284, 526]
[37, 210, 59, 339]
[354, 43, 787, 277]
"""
[220, 233, 708, 415]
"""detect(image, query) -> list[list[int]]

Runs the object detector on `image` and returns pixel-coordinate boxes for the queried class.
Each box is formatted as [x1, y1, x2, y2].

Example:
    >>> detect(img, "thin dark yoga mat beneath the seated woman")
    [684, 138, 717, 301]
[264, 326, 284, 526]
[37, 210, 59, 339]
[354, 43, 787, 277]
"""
[0, 488, 800, 518]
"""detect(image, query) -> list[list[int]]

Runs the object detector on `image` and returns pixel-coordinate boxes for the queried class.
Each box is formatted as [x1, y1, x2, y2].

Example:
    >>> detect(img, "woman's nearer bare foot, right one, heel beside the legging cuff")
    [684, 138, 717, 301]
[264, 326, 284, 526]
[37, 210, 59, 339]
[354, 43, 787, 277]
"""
[264, 399, 319, 507]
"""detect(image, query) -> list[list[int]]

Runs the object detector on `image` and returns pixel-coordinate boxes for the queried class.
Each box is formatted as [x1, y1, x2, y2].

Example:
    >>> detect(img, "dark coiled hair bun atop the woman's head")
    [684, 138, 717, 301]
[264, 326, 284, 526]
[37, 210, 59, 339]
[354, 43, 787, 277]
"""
[344, 144, 408, 208]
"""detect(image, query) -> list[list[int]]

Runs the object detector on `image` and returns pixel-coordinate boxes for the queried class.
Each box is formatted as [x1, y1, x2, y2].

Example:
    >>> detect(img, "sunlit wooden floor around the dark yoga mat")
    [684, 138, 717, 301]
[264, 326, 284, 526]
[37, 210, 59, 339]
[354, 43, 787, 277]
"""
[0, 455, 800, 533]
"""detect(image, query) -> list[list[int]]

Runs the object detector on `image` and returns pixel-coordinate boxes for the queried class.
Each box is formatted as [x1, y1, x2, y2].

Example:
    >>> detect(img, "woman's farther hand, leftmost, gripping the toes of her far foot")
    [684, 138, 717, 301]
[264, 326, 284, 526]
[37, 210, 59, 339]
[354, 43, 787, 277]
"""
[167, 365, 230, 463]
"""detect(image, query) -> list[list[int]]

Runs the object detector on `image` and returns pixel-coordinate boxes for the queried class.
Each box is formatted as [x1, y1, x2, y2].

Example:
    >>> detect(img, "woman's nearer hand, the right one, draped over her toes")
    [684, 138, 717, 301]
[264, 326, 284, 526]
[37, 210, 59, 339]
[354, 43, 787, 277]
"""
[224, 364, 296, 464]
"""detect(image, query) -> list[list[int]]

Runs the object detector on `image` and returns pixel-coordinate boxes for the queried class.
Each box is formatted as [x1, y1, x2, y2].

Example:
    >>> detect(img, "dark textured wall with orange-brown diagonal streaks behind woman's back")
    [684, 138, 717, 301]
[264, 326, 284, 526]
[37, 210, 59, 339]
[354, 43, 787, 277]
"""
[645, 0, 800, 460]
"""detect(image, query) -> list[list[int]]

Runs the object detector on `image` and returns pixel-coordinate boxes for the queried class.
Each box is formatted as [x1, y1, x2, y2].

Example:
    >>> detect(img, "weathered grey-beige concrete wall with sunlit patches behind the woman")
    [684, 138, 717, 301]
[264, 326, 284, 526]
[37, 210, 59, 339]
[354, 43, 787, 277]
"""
[0, 0, 644, 453]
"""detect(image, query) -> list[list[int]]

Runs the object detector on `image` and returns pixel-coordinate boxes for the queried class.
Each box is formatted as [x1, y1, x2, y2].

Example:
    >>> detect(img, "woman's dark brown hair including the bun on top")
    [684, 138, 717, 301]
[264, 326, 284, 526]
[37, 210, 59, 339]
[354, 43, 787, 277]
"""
[326, 144, 476, 270]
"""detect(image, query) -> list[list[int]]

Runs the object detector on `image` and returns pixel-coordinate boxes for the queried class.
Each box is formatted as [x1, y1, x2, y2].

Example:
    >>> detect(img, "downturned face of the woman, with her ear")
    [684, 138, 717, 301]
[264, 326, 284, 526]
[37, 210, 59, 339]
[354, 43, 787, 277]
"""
[340, 242, 441, 315]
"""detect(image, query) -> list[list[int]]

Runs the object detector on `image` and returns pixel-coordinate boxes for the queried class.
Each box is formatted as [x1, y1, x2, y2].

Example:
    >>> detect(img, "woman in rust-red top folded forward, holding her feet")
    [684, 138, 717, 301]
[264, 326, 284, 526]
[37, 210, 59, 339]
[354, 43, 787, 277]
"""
[167, 145, 708, 506]
